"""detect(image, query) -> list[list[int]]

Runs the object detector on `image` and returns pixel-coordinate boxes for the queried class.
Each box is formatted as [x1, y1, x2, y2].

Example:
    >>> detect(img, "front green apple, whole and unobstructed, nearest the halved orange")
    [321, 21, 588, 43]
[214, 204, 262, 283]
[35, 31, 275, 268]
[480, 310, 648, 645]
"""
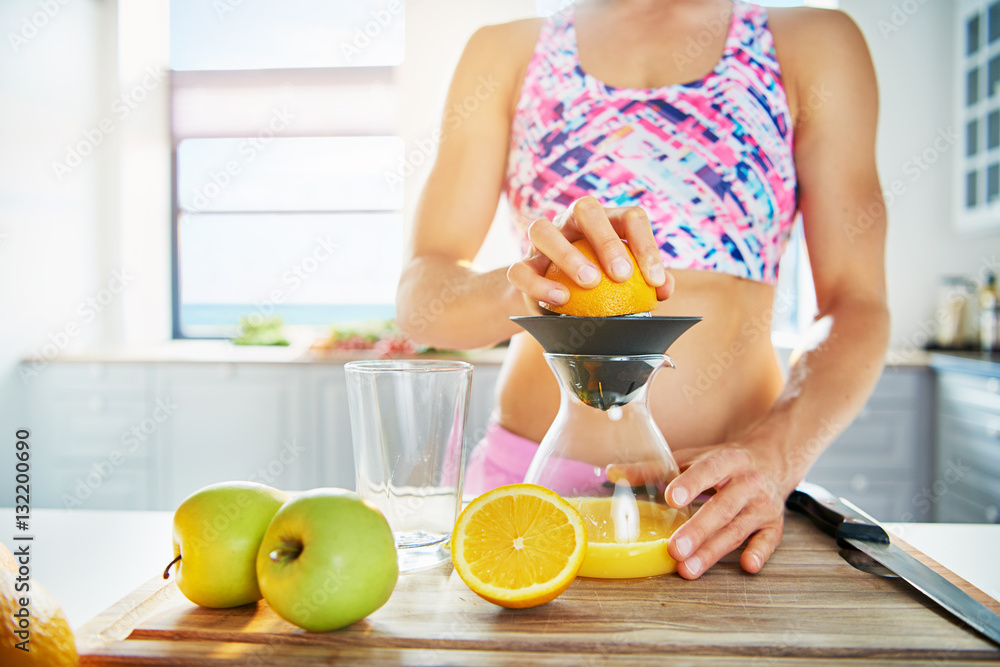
[257, 489, 399, 632]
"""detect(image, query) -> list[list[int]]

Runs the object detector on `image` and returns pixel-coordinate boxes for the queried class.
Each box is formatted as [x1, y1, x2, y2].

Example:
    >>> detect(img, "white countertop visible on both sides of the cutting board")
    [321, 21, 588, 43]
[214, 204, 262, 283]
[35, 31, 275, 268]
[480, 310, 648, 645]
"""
[0, 508, 1000, 628]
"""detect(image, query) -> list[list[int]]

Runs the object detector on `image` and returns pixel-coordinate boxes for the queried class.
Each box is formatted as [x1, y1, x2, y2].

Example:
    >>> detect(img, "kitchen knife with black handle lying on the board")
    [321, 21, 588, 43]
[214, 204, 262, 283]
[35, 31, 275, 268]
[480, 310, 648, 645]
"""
[785, 482, 1000, 645]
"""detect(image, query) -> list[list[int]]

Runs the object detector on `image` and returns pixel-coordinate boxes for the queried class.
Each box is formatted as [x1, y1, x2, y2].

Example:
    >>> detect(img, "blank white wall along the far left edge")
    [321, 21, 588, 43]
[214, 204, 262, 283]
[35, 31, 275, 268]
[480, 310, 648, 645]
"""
[0, 0, 116, 438]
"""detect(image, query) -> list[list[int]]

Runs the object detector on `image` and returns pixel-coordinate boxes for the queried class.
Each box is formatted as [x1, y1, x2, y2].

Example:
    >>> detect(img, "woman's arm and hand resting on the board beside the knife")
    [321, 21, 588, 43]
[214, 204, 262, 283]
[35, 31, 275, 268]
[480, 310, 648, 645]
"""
[667, 10, 889, 579]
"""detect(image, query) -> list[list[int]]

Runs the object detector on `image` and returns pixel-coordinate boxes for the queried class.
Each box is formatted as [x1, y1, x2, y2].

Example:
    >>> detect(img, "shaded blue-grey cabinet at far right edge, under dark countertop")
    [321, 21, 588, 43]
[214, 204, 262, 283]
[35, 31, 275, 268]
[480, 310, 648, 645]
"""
[932, 355, 1000, 523]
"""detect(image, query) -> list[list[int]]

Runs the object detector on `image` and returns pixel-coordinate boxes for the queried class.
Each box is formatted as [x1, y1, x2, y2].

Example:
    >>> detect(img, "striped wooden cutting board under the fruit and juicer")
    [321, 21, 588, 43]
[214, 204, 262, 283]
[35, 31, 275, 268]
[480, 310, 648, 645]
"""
[77, 514, 1000, 666]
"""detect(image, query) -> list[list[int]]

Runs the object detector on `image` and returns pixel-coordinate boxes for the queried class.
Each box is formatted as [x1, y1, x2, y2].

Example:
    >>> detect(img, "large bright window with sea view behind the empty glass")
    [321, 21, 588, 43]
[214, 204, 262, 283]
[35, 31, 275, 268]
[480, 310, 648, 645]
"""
[170, 0, 405, 338]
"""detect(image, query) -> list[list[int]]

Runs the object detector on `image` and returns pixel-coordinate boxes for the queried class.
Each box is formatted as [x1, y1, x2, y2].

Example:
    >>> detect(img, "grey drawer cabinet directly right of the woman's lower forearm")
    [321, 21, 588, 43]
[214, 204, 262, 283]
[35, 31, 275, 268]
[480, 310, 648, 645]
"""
[807, 366, 934, 522]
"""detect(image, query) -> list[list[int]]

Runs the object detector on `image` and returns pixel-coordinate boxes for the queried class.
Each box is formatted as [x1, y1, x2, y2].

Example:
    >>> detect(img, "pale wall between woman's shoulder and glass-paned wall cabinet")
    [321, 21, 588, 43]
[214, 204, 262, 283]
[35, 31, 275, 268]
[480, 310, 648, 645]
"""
[840, 0, 1000, 347]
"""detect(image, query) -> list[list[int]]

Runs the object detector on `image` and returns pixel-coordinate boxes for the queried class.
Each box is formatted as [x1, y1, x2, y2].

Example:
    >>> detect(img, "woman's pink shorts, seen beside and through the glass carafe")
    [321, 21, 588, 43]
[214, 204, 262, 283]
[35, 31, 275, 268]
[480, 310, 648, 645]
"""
[462, 421, 607, 496]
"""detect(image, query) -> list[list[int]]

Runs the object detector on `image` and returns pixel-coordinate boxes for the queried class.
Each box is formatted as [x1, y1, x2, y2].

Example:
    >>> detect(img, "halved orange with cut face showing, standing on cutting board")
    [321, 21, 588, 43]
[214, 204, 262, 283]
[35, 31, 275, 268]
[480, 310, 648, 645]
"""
[451, 484, 587, 608]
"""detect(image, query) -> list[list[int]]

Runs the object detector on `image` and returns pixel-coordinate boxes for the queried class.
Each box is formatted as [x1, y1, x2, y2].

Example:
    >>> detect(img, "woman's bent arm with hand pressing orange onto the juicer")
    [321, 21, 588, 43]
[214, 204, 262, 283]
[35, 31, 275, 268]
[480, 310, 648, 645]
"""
[396, 20, 673, 349]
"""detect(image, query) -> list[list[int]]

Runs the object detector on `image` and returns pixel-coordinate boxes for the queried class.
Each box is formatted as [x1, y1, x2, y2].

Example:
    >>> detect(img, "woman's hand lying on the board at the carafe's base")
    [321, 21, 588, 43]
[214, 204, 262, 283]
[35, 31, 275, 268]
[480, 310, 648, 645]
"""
[665, 443, 795, 579]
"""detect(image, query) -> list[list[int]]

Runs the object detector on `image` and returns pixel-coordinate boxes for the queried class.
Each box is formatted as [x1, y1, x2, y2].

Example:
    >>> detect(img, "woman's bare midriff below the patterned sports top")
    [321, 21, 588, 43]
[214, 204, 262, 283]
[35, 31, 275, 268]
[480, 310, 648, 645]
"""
[497, 271, 784, 450]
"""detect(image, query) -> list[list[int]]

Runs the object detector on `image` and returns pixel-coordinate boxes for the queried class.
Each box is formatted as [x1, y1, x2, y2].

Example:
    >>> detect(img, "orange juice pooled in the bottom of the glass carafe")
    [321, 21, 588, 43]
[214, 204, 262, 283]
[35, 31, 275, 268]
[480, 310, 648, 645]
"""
[567, 494, 687, 579]
